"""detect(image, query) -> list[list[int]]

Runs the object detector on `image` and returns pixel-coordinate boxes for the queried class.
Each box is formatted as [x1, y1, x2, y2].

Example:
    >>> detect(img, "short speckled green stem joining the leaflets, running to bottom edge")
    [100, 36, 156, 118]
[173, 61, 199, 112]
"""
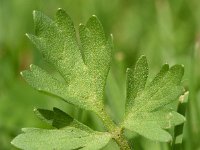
[99, 109, 131, 150]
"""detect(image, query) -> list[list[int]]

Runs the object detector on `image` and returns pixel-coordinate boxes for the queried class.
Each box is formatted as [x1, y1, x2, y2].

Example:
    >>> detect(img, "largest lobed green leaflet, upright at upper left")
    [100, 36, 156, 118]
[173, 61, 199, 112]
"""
[22, 9, 112, 115]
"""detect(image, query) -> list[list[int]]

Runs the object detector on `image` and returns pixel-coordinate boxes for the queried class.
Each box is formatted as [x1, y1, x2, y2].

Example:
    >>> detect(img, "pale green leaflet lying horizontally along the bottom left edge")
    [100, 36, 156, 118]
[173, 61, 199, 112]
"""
[11, 127, 111, 150]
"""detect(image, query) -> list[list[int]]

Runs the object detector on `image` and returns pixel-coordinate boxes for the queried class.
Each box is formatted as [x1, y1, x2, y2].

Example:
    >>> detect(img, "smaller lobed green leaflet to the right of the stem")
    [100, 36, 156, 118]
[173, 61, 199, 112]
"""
[123, 56, 185, 142]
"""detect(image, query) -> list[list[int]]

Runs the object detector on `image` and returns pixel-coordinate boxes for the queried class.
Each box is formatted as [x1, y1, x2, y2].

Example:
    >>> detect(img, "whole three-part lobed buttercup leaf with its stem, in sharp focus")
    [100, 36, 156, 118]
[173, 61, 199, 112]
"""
[12, 9, 185, 150]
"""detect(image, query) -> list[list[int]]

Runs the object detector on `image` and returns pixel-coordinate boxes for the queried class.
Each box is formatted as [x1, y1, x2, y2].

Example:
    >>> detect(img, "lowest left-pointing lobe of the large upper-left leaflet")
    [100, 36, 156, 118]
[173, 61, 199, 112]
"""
[21, 65, 91, 109]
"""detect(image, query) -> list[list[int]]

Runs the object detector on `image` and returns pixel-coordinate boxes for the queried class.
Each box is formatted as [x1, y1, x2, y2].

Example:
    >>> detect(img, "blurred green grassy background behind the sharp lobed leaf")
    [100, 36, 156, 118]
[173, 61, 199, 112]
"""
[0, 0, 200, 150]
